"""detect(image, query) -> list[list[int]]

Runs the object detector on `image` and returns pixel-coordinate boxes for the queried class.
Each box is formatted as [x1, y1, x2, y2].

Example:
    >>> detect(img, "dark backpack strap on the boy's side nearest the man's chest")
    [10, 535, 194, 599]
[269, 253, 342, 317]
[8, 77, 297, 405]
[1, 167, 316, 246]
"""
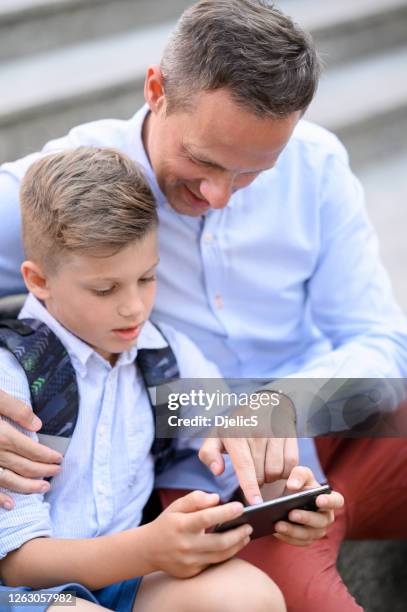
[136, 325, 180, 473]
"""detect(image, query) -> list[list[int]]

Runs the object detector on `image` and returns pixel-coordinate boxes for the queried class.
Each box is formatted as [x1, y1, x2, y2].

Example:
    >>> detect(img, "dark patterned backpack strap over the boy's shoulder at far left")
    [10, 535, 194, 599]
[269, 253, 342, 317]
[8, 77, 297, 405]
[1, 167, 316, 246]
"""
[0, 319, 79, 453]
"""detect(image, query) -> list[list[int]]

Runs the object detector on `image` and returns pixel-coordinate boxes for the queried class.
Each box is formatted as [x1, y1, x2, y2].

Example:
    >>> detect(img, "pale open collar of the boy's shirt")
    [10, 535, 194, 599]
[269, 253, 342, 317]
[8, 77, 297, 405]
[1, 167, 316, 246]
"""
[18, 293, 167, 376]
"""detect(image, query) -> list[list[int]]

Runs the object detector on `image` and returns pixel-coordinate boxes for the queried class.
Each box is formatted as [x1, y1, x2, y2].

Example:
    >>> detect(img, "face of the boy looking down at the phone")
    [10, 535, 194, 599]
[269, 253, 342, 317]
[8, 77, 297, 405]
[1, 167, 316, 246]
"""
[38, 230, 158, 363]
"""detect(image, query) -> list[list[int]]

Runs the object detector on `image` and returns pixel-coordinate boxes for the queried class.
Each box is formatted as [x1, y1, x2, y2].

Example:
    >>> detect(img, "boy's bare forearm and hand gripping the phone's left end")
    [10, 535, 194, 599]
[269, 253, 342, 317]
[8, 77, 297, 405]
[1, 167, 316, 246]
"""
[0, 491, 252, 590]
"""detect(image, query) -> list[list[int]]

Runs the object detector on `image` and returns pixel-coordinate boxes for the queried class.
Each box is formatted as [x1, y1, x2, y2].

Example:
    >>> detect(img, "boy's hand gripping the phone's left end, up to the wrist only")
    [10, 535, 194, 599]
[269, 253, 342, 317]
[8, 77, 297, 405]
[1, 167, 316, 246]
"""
[140, 491, 252, 578]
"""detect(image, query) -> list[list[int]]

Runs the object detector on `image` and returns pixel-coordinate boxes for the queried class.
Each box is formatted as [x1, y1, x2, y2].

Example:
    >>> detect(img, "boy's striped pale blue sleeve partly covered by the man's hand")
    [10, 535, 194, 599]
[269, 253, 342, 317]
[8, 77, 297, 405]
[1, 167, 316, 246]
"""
[0, 349, 52, 558]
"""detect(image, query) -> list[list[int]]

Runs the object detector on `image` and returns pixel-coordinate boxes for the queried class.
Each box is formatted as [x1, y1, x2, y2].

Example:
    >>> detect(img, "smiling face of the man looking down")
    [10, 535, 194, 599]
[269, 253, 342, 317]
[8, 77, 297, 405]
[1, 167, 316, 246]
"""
[143, 89, 300, 217]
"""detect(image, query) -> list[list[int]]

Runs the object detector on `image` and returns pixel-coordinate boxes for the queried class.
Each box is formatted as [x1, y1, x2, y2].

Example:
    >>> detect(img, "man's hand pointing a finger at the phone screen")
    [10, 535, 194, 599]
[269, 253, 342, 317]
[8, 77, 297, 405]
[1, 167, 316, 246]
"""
[199, 437, 298, 504]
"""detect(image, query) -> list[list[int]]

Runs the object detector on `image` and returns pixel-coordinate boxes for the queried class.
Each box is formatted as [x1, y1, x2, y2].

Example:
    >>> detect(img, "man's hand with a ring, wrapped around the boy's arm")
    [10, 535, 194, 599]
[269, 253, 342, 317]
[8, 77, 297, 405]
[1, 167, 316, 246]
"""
[0, 391, 62, 510]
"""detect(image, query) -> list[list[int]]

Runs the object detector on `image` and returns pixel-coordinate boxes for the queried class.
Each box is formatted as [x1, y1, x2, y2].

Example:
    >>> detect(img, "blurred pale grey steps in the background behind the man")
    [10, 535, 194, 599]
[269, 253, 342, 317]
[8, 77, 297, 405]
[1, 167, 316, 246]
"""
[0, 0, 407, 311]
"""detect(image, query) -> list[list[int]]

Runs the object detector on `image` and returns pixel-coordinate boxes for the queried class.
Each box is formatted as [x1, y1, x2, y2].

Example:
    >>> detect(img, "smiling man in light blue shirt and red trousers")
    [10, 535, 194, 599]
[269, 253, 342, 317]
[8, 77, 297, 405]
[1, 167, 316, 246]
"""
[0, 0, 407, 612]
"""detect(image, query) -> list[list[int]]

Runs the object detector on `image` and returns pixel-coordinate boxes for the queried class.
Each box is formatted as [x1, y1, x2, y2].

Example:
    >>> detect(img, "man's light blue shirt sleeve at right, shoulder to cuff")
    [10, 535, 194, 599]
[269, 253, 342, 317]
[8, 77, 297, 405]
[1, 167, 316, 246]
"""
[274, 143, 407, 435]
